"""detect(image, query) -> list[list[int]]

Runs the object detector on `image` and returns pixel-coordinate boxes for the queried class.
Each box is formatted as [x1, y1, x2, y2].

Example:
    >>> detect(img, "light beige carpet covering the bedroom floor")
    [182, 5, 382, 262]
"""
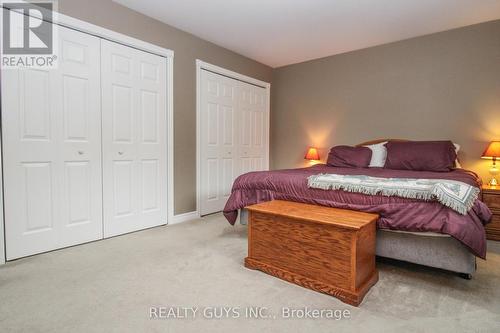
[0, 215, 500, 333]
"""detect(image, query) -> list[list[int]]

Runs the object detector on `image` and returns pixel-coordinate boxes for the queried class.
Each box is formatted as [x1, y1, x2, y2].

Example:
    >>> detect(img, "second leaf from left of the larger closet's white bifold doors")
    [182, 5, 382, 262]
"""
[57, 27, 102, 247]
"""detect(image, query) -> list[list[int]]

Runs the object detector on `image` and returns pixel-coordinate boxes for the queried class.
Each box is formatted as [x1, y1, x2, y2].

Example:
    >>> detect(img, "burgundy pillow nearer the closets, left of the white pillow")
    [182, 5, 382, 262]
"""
[326, 146, 372, 168]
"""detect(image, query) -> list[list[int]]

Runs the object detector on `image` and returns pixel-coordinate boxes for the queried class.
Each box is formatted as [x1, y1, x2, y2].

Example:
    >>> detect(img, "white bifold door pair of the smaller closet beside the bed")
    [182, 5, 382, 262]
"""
[200, 70, 269, 215]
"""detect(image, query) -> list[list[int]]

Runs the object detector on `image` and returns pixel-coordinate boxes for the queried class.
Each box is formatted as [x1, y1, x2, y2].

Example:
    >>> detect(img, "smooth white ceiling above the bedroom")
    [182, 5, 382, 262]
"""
[114, 0, 500, 67]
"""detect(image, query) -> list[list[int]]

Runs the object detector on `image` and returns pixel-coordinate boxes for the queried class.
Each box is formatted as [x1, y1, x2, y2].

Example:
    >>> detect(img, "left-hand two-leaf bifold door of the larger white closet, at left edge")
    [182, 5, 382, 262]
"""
[2, 27, 102, 260]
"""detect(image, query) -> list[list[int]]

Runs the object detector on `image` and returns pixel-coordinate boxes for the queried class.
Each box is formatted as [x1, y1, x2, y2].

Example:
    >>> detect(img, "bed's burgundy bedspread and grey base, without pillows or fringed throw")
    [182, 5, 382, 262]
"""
[224, 139, 491, 278]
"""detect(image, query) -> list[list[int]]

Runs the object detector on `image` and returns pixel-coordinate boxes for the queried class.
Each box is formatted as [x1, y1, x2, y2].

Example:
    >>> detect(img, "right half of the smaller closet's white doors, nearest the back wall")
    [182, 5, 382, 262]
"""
[239, 82, 269, 174]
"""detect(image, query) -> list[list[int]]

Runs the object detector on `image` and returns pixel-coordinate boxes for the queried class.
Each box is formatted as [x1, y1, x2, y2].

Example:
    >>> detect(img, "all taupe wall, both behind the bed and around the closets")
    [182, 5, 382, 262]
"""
[44, 0, 500, 210]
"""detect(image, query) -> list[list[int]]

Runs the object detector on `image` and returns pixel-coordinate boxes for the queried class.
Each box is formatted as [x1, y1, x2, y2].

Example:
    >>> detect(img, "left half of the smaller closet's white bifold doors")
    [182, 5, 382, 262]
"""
[200, 70, 240, 215]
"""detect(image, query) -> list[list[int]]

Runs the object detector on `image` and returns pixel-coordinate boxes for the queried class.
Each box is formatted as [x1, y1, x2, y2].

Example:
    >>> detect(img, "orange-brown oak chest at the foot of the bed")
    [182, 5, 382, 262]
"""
[245, 200, 378, 306]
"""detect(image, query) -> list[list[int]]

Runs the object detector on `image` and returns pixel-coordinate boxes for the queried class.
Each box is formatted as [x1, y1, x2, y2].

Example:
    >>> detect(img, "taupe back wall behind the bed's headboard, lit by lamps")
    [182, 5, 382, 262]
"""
[271, 21, 500, 179]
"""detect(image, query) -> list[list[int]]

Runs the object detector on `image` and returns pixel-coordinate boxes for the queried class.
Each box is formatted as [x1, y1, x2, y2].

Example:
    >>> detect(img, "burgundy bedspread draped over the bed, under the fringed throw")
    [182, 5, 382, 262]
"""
[224, 164, 491, 259]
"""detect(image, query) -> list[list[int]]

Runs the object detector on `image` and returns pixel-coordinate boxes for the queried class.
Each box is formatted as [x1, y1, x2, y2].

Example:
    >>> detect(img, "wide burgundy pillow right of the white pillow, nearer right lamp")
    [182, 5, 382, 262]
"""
[384, 141, 457, 172]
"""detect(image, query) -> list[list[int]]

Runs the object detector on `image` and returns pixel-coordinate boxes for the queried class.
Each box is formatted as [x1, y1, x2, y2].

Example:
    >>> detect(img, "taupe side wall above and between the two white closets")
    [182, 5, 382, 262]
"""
[59, 0, 272, 214]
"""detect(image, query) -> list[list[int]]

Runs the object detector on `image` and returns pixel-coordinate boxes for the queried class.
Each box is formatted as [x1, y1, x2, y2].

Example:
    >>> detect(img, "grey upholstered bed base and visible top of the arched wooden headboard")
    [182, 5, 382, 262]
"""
[240, 139, 476, 279]
